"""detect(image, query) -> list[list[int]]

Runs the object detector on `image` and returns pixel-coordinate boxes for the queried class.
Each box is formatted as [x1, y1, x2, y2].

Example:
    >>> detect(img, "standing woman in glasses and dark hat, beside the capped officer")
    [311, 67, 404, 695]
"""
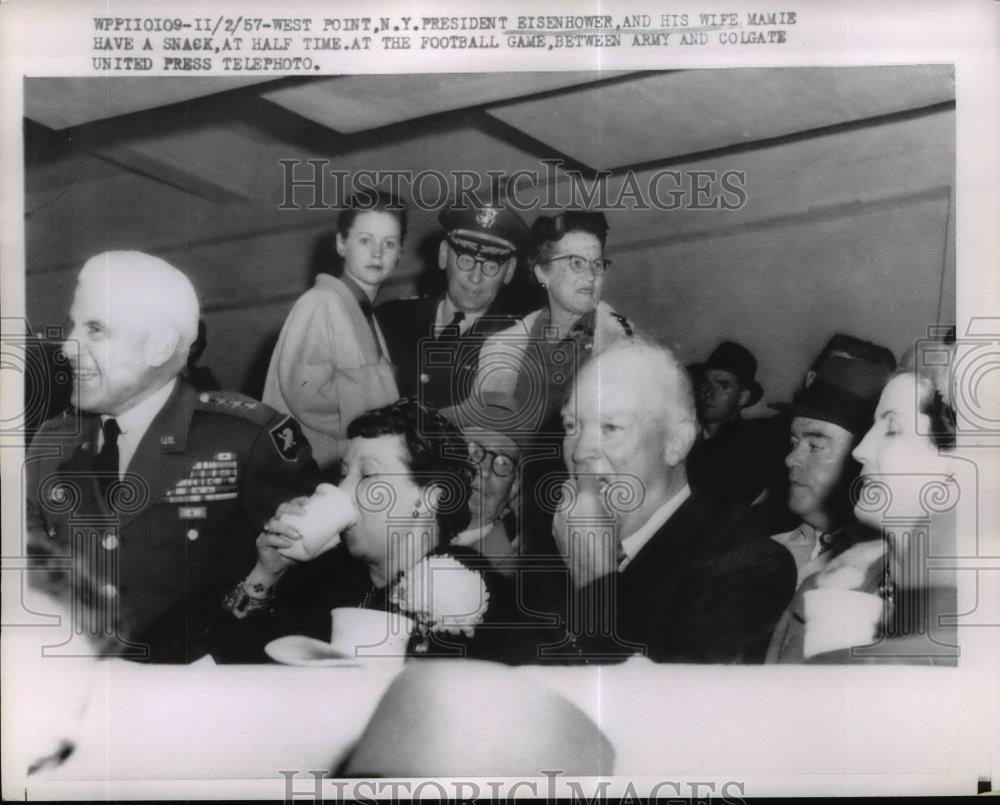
[475, 210, 632, 436]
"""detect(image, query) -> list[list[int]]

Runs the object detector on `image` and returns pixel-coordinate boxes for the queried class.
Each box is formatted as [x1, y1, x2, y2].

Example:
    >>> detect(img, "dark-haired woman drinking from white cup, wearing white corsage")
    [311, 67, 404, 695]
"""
[216, 400, 520, 661]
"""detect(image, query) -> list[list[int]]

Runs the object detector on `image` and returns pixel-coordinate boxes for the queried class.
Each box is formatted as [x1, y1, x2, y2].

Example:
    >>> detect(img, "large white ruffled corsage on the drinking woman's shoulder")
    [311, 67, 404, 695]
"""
[389, 554, 490, 653]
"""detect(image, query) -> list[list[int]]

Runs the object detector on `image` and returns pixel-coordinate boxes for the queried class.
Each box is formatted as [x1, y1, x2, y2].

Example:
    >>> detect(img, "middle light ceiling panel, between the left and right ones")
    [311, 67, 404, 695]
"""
[261, 72, 621, 134]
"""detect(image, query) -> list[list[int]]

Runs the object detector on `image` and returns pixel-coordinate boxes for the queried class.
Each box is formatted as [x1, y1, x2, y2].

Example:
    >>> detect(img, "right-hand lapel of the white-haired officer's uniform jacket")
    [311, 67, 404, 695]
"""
[120, 378, 198, 526]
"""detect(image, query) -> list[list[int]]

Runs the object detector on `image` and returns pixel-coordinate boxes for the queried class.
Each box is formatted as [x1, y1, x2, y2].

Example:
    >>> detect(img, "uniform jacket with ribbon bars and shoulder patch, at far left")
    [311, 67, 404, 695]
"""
[26, 379, 317, 662]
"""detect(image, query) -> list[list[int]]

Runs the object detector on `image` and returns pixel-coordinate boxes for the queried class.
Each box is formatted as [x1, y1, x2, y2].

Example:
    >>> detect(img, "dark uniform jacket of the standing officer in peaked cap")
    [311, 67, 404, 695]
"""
[376, 296, 520, 409]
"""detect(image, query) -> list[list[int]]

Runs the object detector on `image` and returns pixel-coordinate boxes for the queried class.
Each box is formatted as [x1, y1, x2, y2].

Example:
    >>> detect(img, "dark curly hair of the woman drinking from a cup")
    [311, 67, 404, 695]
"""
[347, 398, 475, 545]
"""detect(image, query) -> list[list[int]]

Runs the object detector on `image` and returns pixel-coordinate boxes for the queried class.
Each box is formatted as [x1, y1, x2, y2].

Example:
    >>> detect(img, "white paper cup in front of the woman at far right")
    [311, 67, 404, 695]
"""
[802, 588, 885, 658]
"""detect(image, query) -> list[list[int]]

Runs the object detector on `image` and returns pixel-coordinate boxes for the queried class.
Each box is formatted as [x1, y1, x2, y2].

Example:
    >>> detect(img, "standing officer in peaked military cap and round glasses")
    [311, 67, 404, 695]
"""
[378, 199, 528, 409]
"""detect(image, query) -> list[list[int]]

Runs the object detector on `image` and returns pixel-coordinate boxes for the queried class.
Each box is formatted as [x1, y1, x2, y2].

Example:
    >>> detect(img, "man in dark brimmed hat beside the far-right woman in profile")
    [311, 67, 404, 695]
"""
[771, 356, 889, 585]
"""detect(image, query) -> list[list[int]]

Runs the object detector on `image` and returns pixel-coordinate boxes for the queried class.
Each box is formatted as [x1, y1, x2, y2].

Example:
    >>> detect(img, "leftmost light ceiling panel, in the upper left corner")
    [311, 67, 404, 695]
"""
[24, 76, 274, 129]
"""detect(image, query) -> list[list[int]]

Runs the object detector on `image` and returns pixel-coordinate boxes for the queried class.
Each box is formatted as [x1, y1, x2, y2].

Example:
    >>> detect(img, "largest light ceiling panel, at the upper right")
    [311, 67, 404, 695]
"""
[489, 65, 955, 168]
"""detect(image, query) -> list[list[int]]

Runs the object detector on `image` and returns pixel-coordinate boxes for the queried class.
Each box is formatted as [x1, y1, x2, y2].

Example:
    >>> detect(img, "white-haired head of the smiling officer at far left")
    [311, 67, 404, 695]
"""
[66, 252, 199, 416]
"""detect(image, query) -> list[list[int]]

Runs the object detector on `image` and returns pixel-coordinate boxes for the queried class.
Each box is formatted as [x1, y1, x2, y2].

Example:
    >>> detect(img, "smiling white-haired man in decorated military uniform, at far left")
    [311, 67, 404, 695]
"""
[26, 251, 315, 662]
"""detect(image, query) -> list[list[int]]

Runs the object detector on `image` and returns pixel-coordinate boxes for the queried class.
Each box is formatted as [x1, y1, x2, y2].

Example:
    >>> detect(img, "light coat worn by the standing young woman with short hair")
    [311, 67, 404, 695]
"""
[263, 274, 399, 469]
